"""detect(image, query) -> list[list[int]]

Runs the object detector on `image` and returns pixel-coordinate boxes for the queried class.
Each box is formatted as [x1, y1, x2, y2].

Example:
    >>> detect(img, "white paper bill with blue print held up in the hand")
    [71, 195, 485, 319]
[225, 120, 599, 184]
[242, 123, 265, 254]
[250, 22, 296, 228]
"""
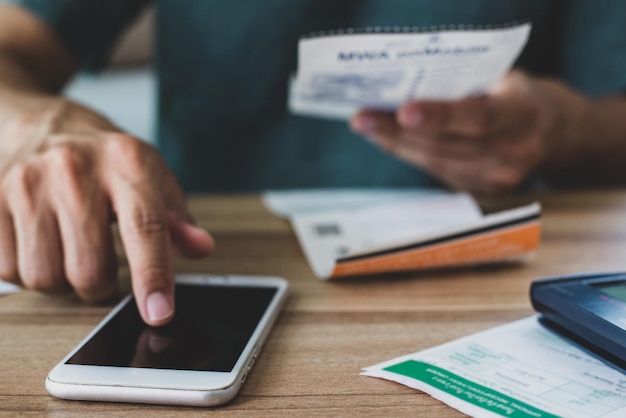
[288, 23, 531, 119]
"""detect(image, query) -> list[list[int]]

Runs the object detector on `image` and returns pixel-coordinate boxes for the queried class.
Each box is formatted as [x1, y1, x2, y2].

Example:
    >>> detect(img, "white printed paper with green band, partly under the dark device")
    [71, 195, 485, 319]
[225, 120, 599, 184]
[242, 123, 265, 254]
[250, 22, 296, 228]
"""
[362, 317, 626, 418]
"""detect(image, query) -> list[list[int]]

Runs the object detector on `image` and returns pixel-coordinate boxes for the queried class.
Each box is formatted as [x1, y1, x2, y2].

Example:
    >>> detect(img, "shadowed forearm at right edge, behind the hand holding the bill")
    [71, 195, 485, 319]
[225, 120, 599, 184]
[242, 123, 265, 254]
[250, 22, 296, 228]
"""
[537, 80, 626, 184]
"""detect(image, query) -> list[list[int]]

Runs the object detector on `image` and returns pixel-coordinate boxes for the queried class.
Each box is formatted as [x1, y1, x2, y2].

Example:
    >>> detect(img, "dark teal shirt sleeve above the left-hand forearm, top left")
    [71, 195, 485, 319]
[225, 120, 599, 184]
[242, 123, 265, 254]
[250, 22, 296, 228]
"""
[0, 0, 149, 71]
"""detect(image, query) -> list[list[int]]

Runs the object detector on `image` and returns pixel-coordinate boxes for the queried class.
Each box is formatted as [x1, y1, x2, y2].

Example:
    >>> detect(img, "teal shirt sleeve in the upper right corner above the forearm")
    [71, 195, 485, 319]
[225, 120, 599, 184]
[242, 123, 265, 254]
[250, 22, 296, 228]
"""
[557, 0, 626, 97]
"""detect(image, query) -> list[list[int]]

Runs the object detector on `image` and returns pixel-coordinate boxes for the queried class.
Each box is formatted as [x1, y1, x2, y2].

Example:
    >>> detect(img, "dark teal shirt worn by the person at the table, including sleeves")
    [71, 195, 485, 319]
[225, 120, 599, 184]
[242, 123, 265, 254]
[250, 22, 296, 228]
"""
[14, 0, 626, 191]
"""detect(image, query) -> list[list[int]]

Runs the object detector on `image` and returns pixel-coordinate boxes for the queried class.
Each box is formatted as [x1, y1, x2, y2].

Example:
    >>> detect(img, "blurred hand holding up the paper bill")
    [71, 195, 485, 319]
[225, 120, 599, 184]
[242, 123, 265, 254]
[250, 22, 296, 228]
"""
[350, 72, 557, 194]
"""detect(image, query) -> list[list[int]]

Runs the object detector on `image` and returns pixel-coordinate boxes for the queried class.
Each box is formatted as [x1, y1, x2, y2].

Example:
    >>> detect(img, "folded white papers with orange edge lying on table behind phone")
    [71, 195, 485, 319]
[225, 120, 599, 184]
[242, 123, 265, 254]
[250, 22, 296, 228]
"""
[264, 190, 541, 279]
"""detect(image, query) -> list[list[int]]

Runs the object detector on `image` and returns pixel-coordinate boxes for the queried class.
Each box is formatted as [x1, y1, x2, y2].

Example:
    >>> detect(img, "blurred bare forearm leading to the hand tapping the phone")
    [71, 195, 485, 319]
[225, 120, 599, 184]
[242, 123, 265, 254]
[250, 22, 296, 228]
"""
[0, 4, 85, 168]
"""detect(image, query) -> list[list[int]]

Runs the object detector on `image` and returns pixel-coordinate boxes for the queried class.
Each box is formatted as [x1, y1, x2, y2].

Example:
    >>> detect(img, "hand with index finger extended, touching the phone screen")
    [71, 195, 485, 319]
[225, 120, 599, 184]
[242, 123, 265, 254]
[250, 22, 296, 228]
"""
[0, 96, 213, 325]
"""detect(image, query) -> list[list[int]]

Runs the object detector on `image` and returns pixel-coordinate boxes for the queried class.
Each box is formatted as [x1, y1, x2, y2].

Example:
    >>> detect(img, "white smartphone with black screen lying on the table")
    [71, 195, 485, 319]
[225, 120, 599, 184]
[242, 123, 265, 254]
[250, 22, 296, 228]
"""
[46, 274, 289, 406]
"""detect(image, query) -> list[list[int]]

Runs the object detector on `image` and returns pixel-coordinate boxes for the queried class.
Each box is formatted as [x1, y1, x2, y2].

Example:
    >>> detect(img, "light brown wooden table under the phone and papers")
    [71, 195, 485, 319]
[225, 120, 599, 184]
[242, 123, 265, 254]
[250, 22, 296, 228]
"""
[0, 190, 626, 417]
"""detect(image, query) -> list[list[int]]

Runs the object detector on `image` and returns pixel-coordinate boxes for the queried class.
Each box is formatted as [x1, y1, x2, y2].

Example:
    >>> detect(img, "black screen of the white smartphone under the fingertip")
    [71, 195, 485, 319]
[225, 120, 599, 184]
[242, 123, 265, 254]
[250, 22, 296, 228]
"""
[66, 284, 277, 372]
